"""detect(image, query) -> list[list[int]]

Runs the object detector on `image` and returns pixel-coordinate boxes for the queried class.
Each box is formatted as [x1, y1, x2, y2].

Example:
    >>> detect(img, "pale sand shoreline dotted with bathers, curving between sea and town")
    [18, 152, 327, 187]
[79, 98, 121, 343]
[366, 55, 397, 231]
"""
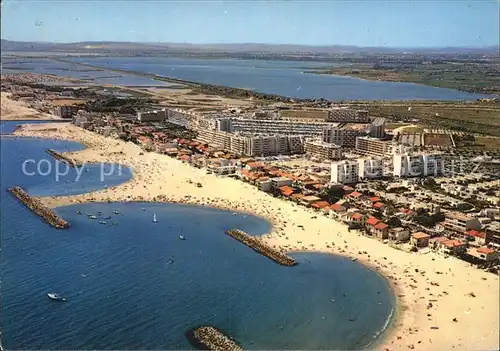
[14, 123, 498, 350]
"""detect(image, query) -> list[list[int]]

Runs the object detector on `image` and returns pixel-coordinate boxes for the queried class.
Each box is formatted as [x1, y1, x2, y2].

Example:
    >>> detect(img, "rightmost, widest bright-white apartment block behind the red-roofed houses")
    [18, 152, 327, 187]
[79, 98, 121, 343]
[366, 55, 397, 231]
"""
[393, 154, 444, 177]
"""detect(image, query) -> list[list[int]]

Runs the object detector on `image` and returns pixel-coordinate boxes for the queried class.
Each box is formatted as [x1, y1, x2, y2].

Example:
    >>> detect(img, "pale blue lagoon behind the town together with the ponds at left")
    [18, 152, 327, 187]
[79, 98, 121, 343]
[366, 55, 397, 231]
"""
[2, 57, 488, 101]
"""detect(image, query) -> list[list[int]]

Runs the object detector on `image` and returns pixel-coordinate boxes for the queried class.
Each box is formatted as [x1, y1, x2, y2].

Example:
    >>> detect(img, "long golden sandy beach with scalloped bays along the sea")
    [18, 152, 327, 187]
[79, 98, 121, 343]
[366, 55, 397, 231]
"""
[11, 122, 500, 350]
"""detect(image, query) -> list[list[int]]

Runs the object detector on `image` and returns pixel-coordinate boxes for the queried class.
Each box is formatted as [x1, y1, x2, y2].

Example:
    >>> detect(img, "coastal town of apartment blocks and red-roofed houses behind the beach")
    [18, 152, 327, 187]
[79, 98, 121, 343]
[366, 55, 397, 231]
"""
[2, 74, 500, 273]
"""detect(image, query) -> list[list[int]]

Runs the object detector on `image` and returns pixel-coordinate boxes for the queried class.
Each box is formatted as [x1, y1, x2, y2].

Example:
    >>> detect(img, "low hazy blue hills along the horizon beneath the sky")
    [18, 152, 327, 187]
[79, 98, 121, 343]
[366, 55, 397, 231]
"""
[1, 39, 500, 56]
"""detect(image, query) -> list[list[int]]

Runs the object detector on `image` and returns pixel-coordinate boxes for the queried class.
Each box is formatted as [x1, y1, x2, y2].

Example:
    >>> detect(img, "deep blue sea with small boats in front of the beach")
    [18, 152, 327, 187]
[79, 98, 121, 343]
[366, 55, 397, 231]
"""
[0, 122, 395, 350]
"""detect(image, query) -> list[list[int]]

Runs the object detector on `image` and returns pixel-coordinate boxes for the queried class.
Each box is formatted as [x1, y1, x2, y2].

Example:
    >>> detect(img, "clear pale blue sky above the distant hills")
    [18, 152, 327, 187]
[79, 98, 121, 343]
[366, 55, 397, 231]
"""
[2, 0, 500, 47]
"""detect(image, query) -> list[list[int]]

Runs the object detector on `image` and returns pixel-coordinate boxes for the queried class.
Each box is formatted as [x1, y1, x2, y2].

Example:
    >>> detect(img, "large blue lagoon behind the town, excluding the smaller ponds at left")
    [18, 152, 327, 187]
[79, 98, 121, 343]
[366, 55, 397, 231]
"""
[64, 57, 485, 101]
